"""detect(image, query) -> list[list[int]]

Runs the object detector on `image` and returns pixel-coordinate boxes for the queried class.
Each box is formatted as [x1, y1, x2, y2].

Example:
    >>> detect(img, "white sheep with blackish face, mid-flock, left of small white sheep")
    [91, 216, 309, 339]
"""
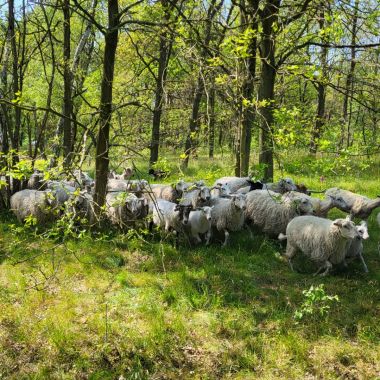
[152, 199, 192, 233]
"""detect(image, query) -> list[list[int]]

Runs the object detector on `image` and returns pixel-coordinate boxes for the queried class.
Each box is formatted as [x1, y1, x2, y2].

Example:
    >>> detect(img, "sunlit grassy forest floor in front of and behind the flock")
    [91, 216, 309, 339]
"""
[0, 156, 380, 379]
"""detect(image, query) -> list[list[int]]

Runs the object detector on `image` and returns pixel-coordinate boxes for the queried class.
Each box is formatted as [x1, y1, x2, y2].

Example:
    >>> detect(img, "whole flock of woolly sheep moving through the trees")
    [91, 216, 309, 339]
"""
[2, 169, 380, 275]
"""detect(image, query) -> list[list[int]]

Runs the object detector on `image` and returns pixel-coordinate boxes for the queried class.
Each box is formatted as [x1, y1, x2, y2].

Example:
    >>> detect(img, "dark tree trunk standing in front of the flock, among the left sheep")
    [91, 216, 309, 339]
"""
[94, 0, 119, 214]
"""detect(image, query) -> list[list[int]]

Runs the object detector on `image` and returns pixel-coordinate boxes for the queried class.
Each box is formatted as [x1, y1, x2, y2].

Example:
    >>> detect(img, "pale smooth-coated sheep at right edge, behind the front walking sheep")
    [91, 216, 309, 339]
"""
[326, 187, 380, 220]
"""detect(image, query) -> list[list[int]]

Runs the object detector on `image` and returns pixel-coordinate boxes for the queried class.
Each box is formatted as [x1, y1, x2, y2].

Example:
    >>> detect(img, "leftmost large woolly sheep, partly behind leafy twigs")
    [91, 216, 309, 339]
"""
[10, 189, 58, 224]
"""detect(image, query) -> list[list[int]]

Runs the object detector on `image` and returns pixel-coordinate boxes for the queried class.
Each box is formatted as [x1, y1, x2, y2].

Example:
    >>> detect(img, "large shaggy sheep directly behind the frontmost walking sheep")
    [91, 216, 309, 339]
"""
[246, 190, 313, 237]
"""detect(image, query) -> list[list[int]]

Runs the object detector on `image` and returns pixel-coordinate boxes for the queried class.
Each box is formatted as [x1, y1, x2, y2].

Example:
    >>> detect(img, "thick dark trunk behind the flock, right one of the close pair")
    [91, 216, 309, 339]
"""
[258, 0, 281, 182]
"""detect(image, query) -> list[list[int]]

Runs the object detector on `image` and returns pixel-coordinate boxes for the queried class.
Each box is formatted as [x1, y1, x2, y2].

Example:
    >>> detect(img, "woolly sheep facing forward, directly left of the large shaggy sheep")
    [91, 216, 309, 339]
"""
[211, 194, 246, 247]
